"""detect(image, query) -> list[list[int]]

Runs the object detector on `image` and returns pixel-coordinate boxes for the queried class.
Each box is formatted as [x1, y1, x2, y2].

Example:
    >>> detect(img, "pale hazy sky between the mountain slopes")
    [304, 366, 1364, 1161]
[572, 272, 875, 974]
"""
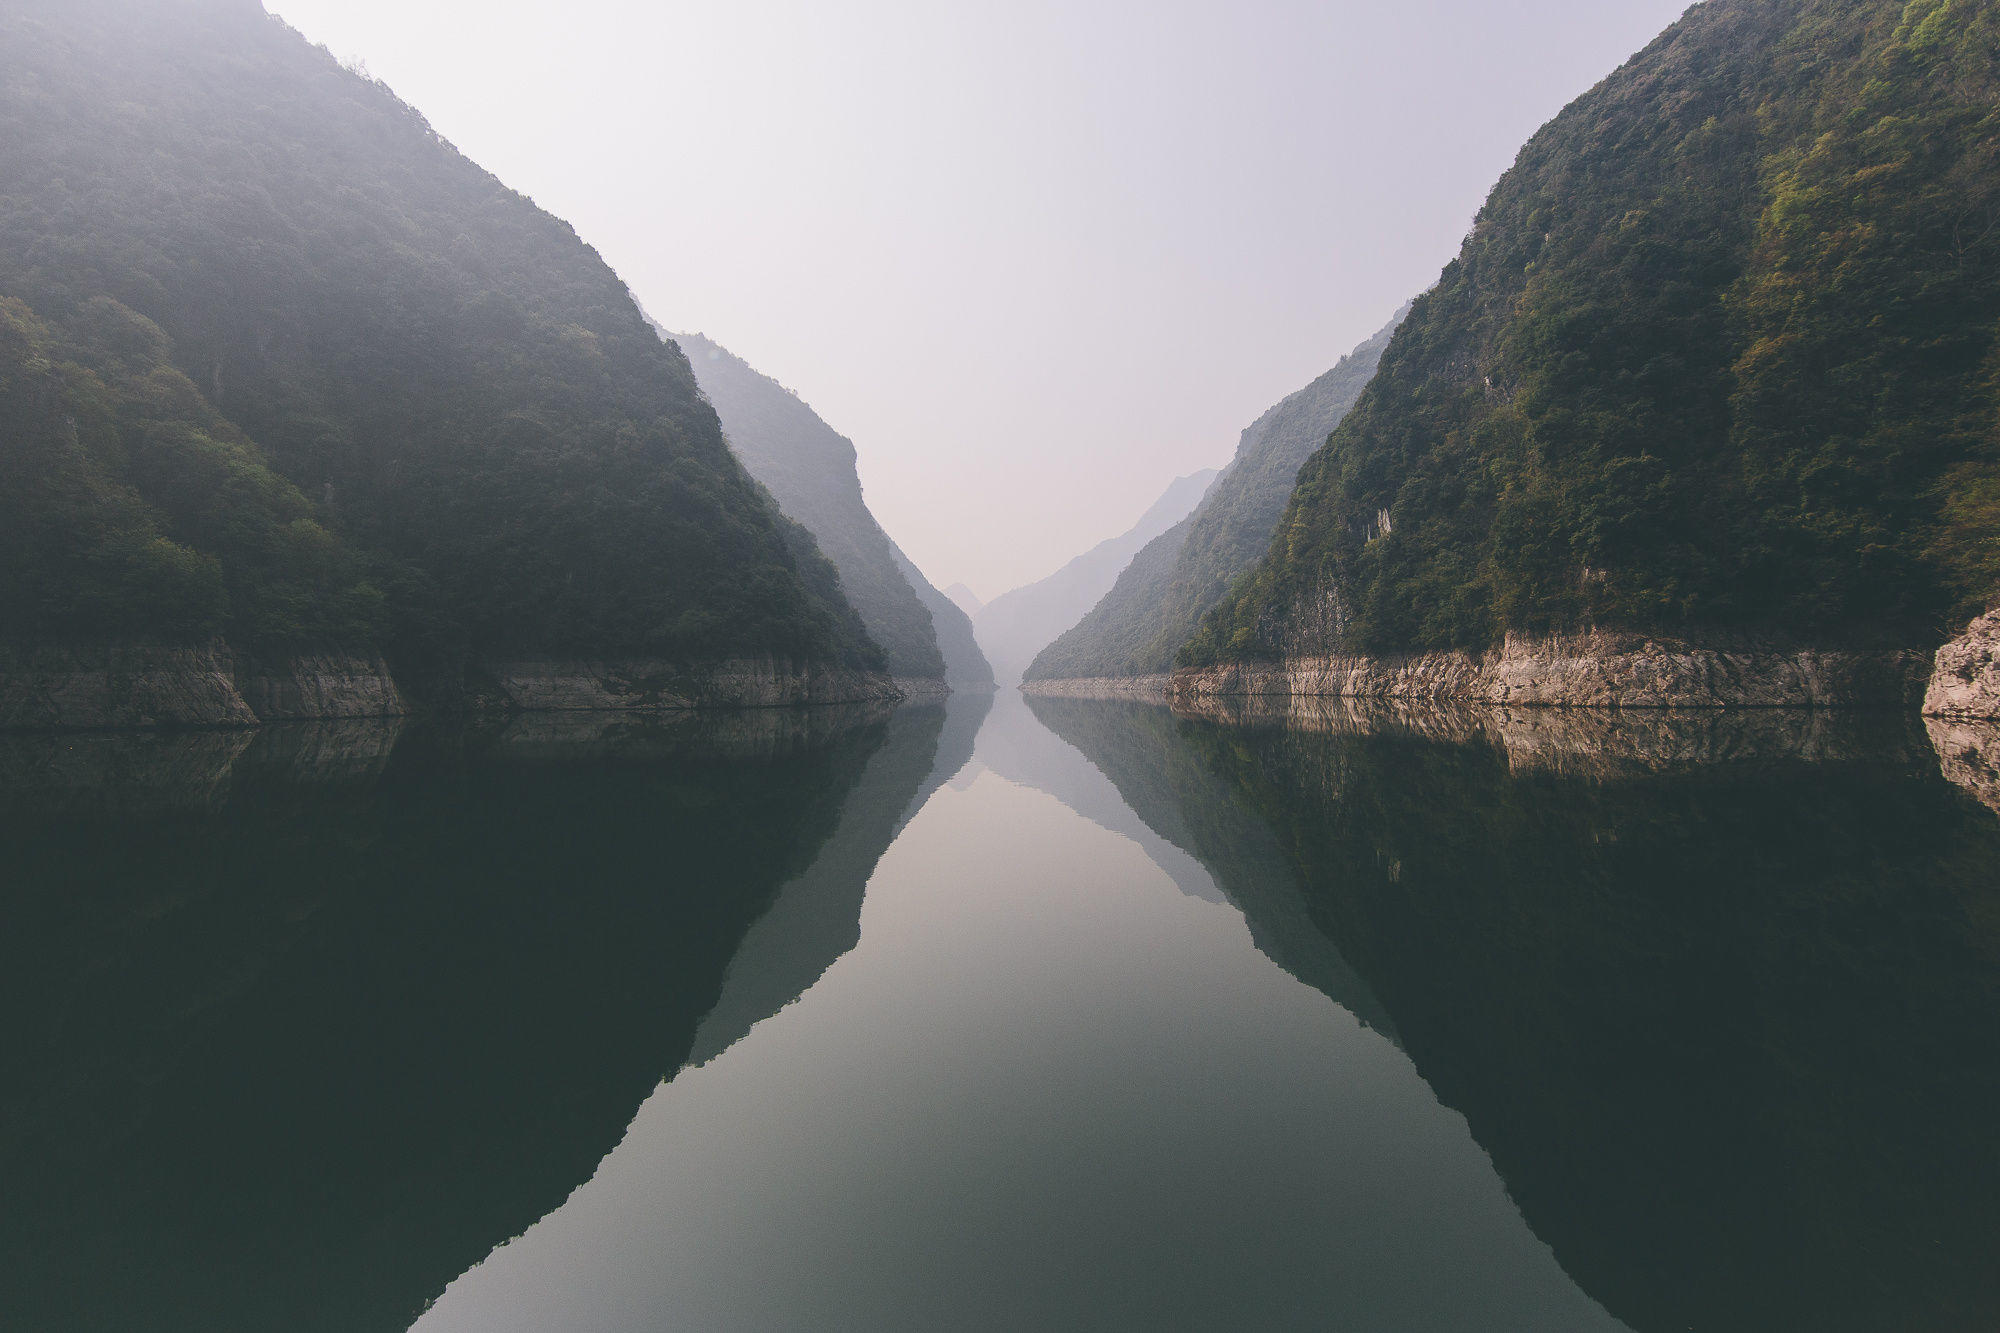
[266, 0, 1686, 598]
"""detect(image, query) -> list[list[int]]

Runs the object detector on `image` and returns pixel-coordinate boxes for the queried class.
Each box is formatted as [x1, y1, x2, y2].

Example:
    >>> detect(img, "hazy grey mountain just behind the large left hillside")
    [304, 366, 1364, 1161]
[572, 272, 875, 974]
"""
[670, 334, 990, 681]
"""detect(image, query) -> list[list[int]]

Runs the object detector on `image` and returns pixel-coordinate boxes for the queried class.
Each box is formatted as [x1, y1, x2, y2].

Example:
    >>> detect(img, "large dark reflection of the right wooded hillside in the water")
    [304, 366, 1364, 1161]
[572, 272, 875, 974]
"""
[1182, 700, 2000, 1331]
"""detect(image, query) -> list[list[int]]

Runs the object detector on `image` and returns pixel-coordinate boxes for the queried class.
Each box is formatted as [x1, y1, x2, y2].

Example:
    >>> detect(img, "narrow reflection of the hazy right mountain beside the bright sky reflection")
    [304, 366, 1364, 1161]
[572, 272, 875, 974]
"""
[1028, 697, 1396, 1041]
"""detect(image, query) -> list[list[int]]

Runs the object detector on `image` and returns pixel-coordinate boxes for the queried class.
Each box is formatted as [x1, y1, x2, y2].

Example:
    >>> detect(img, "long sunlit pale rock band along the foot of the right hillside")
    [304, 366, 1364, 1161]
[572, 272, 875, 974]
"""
[1168, 630, 1928, 709]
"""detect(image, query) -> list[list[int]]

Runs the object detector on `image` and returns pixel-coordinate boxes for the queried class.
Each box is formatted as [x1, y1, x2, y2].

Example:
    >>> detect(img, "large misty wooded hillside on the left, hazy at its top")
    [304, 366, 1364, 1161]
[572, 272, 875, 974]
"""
[0, 0, 878, 667]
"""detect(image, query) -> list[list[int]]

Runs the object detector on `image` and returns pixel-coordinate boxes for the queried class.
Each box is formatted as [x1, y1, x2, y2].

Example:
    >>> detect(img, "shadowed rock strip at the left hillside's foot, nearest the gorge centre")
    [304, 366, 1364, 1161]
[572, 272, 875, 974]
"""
[486, 656, 902, 713]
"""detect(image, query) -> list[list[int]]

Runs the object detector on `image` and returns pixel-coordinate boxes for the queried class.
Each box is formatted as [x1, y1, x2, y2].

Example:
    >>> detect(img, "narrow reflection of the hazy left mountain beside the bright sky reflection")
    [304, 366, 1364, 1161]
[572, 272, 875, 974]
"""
[688, 693, 992, 1065]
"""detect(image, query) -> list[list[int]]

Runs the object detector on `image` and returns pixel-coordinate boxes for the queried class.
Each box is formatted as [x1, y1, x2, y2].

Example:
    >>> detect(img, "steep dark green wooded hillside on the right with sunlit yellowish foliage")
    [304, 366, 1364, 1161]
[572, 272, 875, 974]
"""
[1186, 0, 2000, 662]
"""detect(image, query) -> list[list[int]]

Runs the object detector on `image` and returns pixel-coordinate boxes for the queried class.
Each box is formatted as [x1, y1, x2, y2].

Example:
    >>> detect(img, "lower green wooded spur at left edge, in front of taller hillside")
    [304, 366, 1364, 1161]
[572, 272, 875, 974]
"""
[0, 298, 384, 646]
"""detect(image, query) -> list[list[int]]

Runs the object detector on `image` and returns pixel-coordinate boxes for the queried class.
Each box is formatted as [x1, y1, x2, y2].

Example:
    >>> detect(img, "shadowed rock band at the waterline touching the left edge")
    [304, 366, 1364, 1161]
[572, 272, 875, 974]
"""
[0, 644, 258, 731]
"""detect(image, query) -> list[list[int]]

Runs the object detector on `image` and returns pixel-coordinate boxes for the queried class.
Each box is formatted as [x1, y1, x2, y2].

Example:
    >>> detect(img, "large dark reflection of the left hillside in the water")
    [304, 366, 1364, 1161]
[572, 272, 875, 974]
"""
[0, 711, 886, 1333]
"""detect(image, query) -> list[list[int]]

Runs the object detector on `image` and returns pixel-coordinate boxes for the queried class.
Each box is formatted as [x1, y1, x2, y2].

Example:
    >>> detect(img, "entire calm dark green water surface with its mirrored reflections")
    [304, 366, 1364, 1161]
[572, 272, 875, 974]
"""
[0, 697, 2000, 1333]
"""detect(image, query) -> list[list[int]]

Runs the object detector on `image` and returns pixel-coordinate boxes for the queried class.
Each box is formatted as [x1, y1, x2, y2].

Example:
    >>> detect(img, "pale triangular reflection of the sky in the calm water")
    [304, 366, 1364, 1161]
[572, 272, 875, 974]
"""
[416, 697, 1618, 1333]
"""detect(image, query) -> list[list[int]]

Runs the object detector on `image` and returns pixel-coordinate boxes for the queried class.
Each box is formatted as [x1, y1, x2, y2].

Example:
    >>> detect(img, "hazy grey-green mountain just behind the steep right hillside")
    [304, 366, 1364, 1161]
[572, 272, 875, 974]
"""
[1026, 306, 1410, 681]
